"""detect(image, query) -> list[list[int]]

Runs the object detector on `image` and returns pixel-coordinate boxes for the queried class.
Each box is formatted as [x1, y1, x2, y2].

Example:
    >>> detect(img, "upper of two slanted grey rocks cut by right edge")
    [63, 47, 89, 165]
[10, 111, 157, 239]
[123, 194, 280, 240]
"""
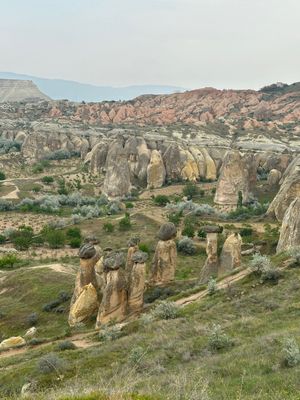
[267, 156, 300, 221]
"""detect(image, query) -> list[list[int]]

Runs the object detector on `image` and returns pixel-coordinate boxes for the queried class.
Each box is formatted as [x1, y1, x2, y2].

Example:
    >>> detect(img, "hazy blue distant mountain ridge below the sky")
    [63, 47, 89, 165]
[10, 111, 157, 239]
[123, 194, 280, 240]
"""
[0, 72, 185, 102]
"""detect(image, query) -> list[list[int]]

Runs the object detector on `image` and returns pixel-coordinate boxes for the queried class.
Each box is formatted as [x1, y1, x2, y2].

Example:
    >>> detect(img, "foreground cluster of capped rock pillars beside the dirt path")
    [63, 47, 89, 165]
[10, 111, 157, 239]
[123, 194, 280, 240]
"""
[69, 223, 242, 328]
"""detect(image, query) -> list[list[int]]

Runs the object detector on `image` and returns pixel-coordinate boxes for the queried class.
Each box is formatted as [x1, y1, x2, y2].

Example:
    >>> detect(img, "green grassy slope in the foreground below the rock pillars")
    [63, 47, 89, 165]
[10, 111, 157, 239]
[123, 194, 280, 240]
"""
[0, 252, 300, 400]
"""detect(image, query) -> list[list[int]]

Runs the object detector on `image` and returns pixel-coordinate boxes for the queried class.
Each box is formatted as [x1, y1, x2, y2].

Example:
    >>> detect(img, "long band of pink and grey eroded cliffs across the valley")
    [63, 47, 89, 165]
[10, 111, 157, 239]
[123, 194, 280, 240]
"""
[0, 84, 300, 198]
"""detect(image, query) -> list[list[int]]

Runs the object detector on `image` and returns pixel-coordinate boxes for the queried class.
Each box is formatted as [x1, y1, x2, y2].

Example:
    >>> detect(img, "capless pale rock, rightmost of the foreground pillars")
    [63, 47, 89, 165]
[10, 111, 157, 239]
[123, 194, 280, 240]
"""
[218, 233, 242, 275]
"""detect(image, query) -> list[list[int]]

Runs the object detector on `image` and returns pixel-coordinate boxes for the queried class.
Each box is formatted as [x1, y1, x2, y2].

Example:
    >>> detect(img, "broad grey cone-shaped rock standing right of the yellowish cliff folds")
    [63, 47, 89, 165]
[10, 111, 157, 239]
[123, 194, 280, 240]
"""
[214, 150, 256, 206]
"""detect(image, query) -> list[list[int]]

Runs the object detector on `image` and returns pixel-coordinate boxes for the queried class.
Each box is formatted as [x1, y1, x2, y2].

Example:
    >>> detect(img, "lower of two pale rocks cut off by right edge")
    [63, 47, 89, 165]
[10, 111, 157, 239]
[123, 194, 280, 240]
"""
[277, 197, 300, 253]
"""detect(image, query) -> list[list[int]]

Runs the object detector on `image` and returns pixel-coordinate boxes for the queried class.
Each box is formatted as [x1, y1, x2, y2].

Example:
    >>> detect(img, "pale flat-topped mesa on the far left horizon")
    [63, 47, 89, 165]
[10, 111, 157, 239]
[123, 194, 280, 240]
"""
[0, 79, 49, 103]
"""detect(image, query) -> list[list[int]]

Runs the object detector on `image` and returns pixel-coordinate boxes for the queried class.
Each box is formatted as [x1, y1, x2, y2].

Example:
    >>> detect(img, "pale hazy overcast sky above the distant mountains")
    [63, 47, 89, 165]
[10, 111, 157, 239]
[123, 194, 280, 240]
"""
[0, 0, 300, 88]
